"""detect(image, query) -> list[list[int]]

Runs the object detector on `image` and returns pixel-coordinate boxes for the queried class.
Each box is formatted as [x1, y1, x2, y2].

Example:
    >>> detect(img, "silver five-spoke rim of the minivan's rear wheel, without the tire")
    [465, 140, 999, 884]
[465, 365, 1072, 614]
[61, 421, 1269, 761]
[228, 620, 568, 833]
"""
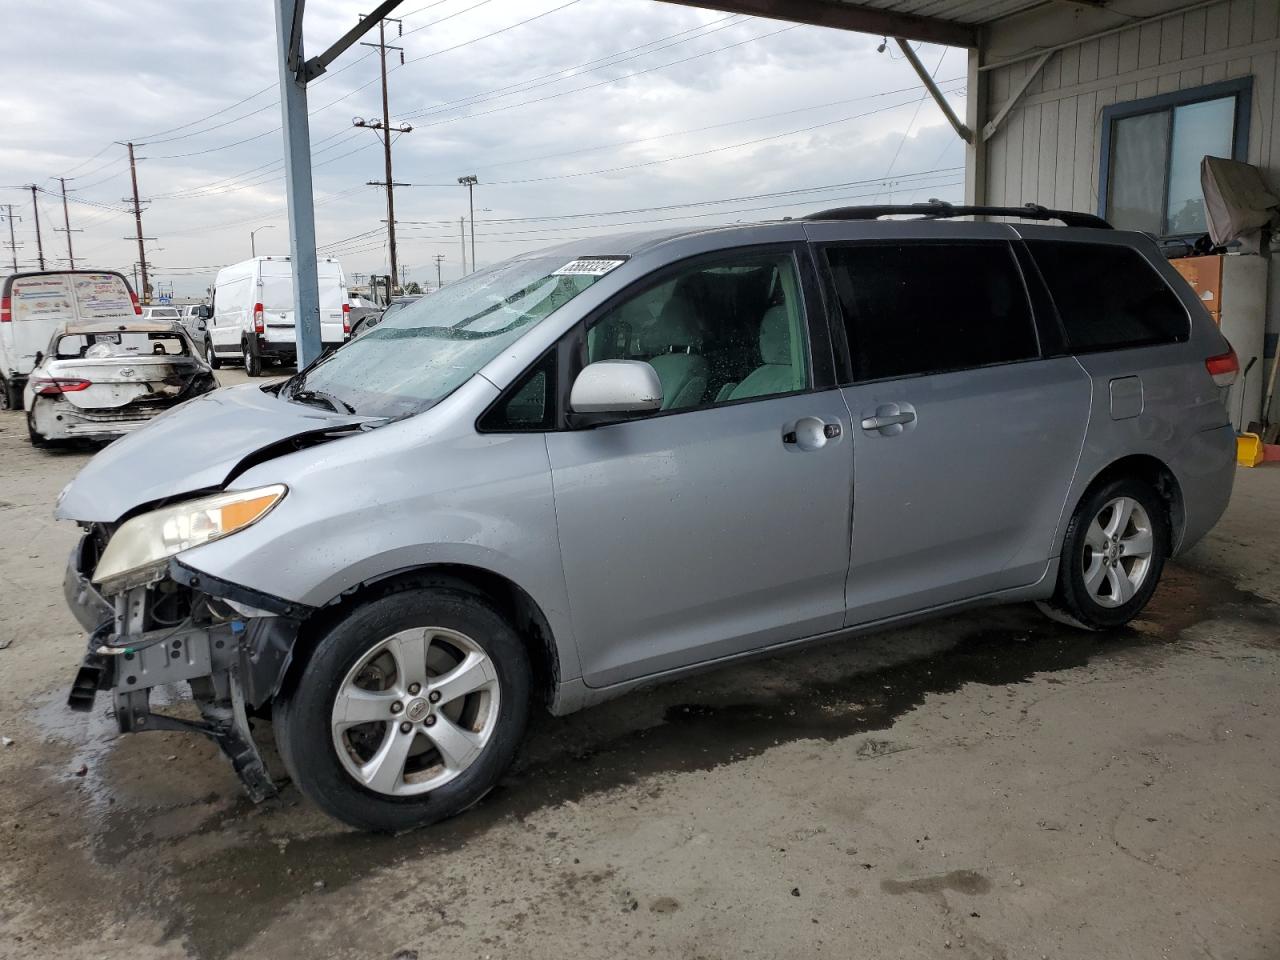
[1082, 497, 1155, 607]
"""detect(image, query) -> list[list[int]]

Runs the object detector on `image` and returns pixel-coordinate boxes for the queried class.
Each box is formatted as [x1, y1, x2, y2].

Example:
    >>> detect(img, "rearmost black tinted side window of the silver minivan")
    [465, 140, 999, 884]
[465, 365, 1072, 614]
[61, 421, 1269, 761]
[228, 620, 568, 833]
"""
[1027, 241, 1190, 353]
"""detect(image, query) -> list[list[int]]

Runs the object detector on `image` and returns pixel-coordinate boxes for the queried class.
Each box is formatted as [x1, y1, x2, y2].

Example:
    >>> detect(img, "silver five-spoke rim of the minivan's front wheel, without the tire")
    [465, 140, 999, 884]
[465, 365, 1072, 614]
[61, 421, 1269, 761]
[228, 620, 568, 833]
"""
[330, 627, 500, 796]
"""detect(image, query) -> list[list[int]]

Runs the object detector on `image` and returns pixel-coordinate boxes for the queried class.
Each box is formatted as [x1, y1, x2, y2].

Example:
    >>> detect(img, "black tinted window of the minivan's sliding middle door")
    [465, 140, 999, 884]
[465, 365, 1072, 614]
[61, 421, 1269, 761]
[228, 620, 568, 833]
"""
[826, 242, 1039, 380]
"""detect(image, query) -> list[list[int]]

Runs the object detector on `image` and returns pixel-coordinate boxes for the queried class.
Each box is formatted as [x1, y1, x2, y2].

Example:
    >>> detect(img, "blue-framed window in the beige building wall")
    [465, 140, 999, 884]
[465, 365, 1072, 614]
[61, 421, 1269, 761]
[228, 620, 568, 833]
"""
[1098, 77, 1253, 237]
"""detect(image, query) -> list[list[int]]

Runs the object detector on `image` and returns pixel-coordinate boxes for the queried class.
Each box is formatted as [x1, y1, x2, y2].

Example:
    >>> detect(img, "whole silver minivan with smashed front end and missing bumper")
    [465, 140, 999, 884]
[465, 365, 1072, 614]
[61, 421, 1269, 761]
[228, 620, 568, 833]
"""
[56, 205, 1236, 831]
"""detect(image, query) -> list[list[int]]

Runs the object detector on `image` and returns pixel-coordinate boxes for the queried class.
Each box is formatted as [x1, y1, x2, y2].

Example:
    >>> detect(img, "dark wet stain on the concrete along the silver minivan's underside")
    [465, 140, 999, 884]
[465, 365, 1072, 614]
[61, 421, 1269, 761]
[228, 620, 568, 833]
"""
[12, 567, 1280, 960]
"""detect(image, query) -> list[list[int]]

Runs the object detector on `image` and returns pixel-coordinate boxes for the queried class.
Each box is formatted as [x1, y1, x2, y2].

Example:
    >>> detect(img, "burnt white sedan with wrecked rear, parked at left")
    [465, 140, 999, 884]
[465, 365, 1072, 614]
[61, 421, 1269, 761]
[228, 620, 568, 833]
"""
[23, 321, 218, 447]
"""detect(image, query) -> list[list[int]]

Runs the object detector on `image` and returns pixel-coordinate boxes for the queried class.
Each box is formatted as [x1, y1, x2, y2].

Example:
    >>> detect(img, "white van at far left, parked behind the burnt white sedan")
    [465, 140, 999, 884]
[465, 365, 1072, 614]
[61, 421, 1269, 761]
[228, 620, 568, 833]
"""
[0, 270, 142, 410]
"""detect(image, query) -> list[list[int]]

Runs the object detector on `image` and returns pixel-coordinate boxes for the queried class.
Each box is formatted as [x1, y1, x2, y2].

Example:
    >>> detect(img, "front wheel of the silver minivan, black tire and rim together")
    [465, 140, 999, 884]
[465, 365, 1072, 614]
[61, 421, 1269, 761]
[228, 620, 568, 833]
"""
[273, 584, 531, 833]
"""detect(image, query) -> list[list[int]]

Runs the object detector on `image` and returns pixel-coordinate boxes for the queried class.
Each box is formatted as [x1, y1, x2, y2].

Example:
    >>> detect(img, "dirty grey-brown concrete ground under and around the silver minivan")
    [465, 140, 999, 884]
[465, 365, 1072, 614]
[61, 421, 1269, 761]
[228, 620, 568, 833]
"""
[0, 371, 1280, 960]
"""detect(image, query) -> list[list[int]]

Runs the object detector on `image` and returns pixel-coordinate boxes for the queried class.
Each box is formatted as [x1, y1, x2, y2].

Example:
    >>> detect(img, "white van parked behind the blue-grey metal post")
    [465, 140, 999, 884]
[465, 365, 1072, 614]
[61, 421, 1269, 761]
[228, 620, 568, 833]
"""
[204, 256, 351, 376]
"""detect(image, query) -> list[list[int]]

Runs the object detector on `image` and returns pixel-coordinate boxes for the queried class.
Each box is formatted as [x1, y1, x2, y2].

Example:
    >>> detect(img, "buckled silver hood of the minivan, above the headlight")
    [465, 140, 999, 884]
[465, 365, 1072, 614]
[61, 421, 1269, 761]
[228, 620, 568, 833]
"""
[54, 384, 373, 524]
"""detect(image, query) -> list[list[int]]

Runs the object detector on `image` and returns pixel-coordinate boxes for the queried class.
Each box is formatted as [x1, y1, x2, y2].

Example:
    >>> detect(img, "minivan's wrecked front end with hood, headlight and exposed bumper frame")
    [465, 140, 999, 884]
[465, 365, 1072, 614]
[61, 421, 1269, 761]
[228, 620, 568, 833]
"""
[55, 388, 373, 800]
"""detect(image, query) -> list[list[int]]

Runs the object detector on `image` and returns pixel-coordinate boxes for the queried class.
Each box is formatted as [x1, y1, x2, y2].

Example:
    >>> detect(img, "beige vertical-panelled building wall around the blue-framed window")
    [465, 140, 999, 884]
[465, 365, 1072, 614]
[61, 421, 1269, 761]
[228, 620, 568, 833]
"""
[987, 0, 1280, 411]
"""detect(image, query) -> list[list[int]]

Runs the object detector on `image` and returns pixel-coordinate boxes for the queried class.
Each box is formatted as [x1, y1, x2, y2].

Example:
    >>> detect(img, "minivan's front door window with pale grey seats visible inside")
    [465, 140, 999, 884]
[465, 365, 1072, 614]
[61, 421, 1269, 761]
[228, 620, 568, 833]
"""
[586, 251, 809, 410]
